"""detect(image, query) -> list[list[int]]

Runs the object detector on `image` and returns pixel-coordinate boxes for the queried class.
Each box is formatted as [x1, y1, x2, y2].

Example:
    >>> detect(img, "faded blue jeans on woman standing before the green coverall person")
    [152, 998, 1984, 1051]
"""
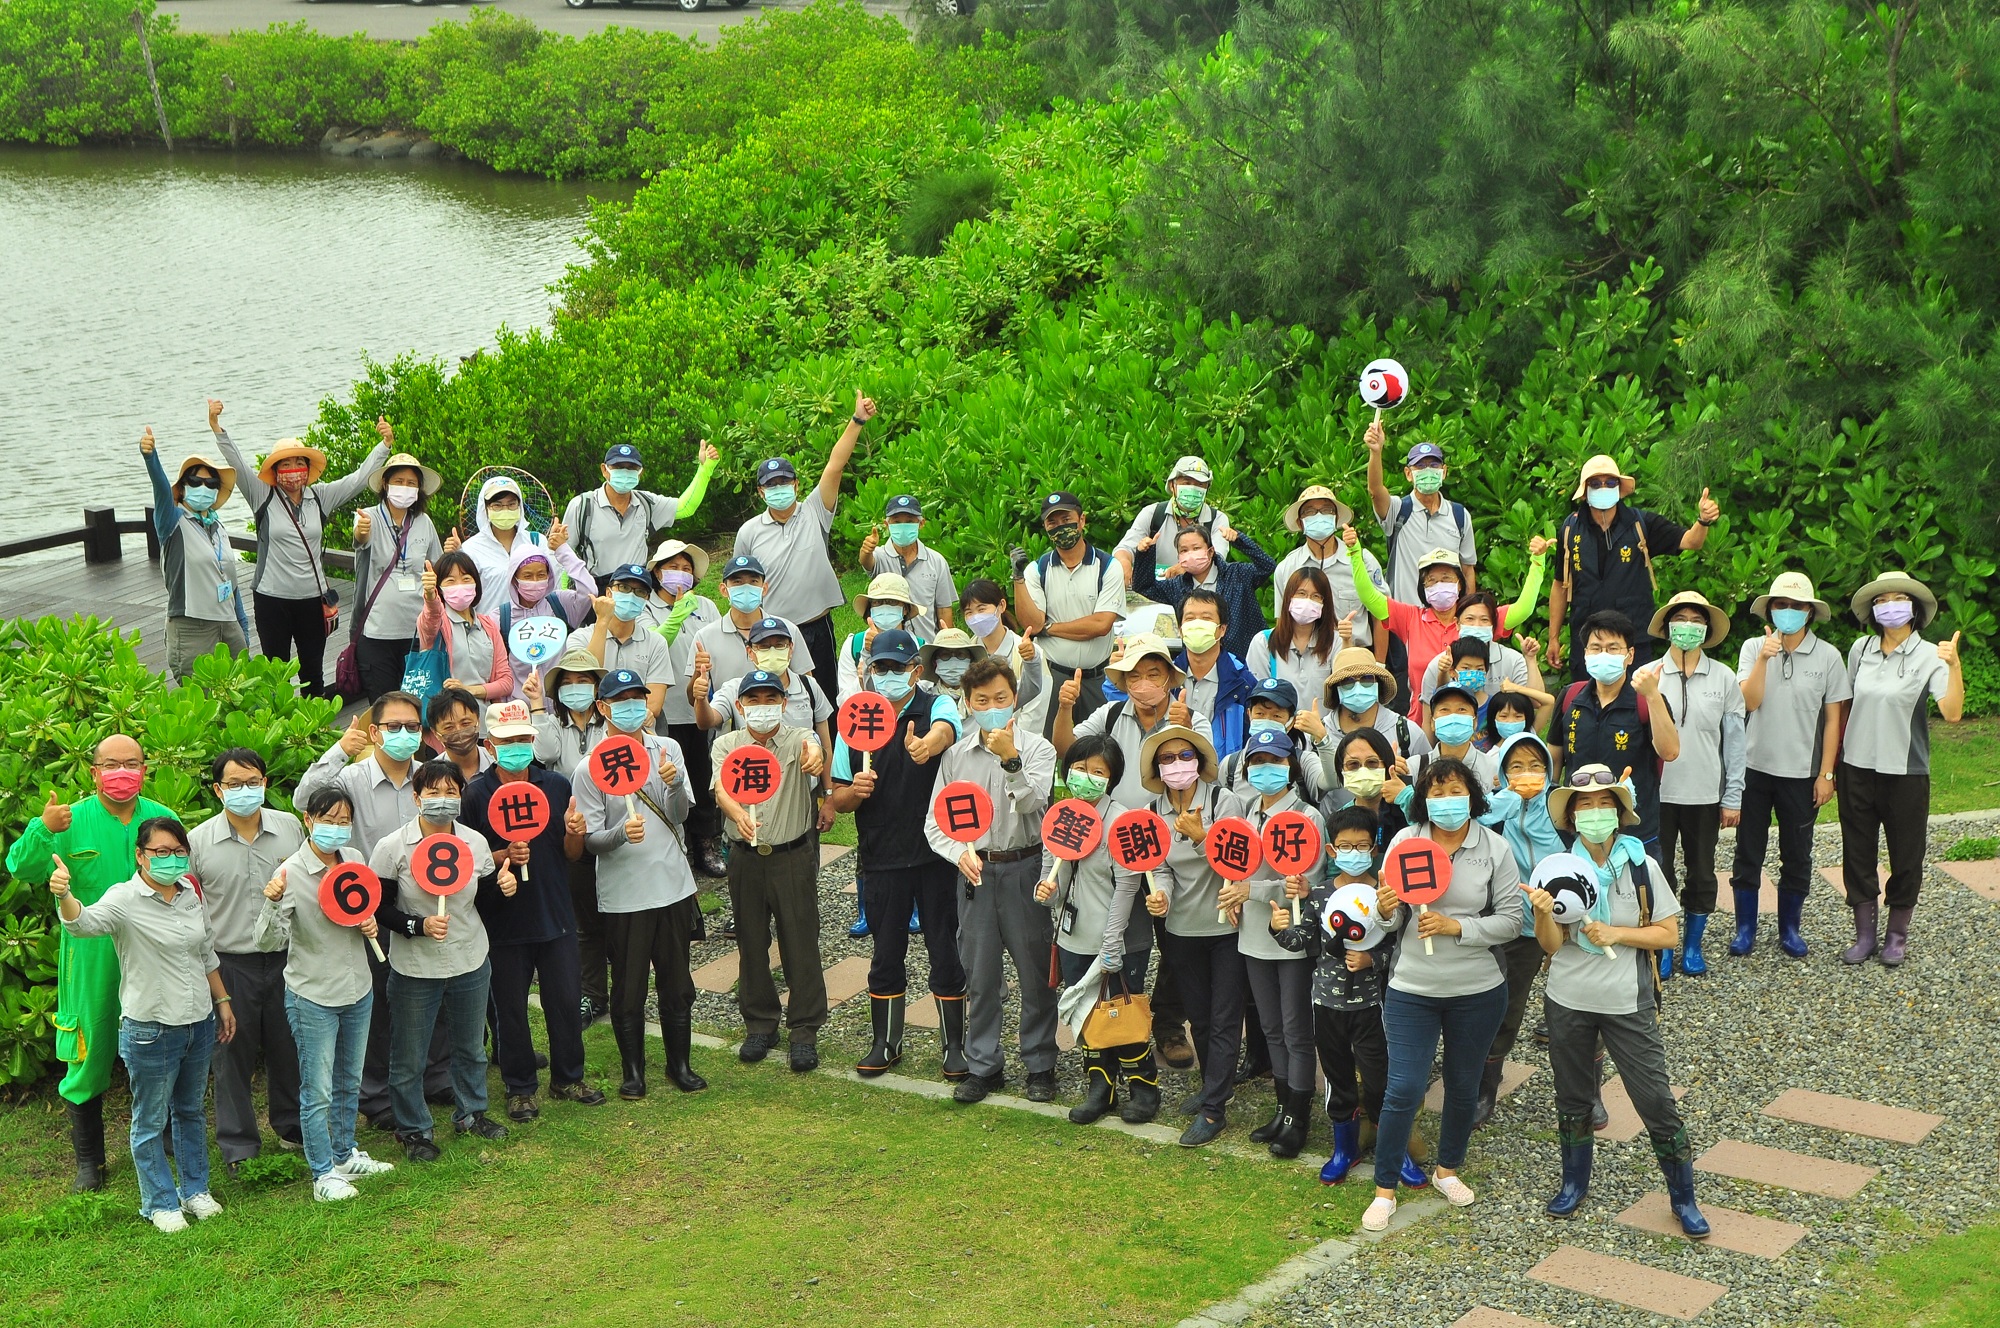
[118, 1014, 216, 1218]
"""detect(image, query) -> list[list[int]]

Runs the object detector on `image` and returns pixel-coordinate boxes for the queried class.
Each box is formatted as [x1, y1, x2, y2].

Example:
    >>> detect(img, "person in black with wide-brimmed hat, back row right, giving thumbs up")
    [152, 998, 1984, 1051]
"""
[1548, 456, 1722, 682]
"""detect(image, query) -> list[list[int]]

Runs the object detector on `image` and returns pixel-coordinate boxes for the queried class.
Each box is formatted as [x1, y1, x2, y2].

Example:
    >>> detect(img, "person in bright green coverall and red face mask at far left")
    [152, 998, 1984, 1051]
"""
[6, 734, 174, 1192]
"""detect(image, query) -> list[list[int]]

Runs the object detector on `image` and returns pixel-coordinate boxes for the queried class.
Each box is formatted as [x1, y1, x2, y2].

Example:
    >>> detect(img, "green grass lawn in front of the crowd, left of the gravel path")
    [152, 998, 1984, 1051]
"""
[0, 1026, 1368, 1328]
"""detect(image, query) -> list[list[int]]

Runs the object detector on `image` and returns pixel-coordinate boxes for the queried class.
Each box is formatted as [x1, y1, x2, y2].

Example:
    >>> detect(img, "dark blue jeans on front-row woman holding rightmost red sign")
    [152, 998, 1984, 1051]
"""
[1376, 982, 1506, 1190]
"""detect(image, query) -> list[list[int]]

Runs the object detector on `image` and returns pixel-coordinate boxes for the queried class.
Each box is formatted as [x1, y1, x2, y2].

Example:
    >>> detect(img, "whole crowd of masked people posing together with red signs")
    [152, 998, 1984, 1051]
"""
[27, 394, 1964, 1236]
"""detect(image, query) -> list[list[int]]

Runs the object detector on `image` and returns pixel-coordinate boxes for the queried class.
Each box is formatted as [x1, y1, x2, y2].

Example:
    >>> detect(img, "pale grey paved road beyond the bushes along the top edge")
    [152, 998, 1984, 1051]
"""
[160, 0, 908, 40]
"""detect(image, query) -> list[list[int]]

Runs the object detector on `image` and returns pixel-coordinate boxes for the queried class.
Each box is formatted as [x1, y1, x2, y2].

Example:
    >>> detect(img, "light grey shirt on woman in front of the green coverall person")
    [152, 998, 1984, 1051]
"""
[62, 872, 222, 1026]
